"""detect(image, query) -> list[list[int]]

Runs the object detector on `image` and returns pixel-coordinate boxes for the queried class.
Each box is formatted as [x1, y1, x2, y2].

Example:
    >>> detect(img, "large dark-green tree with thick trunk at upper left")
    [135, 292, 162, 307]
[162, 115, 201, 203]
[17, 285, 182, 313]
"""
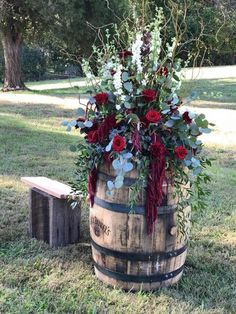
[0, 0, 129, 90]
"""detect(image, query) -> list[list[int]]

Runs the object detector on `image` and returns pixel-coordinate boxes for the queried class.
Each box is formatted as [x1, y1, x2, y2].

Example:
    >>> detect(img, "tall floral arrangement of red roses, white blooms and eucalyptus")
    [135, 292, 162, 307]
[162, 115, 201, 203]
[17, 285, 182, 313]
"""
[64, 9, 210, 233]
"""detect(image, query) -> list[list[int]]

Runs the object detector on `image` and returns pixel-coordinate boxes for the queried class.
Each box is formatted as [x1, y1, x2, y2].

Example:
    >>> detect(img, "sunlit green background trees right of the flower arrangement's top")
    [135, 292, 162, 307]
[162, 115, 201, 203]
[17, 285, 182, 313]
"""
[130, 0, 236, 66]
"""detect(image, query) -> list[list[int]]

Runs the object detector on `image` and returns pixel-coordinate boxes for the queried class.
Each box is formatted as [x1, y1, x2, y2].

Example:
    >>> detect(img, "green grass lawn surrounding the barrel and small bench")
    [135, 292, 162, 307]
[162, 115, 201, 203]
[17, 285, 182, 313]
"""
[0, 80, 236, 314]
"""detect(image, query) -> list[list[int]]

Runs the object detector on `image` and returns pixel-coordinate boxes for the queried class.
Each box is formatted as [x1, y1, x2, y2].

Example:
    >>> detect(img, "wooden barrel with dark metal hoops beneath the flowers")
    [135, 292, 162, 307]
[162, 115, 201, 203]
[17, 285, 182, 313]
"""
[90, 166, 189, 291]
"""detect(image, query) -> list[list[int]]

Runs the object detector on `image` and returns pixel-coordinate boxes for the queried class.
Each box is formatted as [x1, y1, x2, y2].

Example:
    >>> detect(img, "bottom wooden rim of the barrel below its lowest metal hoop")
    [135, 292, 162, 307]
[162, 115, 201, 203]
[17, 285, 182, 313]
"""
[94, 266, 183, 292]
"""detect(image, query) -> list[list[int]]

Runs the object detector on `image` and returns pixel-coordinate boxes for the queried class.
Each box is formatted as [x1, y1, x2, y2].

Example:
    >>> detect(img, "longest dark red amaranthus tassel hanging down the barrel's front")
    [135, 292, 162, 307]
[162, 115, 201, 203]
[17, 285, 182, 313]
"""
[145, 140, 166, 234]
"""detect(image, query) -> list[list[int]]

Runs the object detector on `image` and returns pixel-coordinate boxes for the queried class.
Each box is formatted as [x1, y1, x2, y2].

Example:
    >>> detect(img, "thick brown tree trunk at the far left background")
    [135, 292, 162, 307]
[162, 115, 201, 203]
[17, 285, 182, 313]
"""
[2, 32, 26, 91]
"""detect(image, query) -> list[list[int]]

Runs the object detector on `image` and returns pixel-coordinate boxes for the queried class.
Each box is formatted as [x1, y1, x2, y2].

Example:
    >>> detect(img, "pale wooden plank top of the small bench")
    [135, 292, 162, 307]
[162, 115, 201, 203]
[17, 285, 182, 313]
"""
[21, 177, 72, 199]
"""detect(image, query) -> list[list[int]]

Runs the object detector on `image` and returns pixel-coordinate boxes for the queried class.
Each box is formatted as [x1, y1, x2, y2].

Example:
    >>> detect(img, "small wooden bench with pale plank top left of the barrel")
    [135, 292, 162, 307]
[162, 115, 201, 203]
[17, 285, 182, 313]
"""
[21, 177, 81, 247]
